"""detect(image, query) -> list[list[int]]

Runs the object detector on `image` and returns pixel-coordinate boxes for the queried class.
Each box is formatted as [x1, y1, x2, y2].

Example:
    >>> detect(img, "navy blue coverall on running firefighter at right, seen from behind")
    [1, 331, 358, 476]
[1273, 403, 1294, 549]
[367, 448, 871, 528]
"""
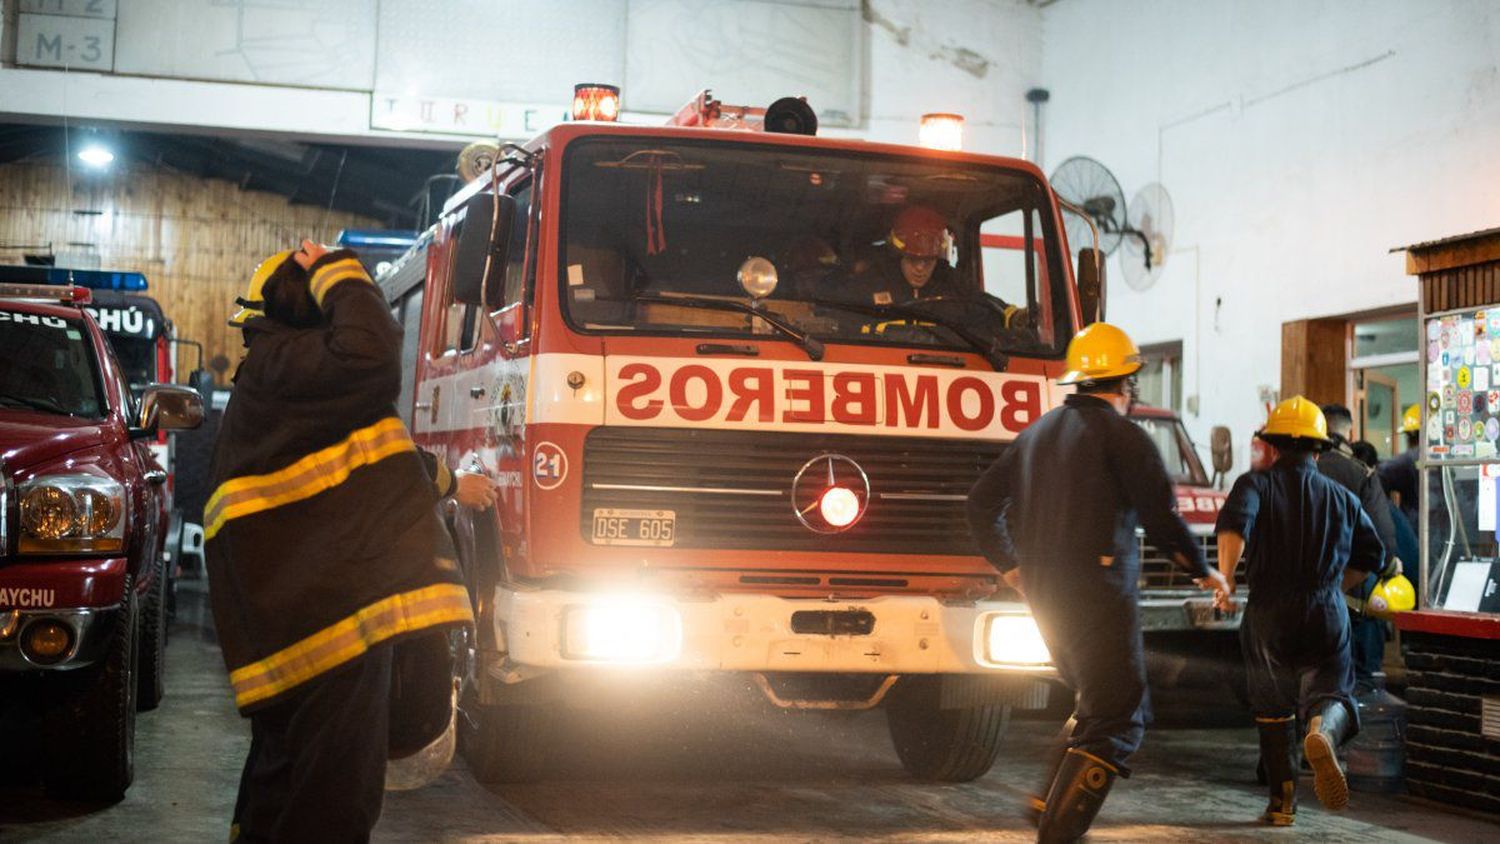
[1215, 456, 1386, 725]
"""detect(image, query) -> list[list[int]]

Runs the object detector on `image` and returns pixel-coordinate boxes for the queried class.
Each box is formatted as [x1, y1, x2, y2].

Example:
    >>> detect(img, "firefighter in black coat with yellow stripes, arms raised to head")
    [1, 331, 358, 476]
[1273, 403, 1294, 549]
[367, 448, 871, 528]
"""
[204, 241, 471, 841]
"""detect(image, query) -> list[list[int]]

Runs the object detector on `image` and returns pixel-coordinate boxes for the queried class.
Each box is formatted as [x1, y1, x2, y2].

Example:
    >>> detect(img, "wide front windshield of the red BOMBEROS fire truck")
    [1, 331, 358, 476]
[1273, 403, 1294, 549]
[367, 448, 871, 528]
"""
[560, 138, 1070, 360]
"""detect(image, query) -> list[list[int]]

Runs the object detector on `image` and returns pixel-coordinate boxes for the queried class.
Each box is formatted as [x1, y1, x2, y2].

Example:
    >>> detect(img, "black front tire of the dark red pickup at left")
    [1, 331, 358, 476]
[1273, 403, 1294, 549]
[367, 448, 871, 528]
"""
[42, 579, 140, 802]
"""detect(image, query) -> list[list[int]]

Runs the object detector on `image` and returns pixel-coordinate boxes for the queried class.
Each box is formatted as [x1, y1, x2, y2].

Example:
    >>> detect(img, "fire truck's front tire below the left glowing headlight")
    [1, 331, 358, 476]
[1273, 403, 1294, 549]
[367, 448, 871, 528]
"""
[458, 700, 557, 783]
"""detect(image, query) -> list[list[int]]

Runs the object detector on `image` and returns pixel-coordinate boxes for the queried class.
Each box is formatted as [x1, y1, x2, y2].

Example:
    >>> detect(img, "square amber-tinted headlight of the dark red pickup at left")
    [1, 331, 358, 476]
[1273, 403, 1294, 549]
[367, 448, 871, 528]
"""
[17, 474, 125, 553]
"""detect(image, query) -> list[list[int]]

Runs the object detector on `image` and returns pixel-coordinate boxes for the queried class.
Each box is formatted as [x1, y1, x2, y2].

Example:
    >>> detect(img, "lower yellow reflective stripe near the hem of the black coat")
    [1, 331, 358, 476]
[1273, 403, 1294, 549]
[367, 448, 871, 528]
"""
[230, 583, 474, 708]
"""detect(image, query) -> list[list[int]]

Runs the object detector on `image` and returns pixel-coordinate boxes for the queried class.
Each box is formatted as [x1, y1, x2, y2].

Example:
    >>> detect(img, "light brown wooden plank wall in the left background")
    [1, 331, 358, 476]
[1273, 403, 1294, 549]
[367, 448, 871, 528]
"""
[0, 162, 380, 375]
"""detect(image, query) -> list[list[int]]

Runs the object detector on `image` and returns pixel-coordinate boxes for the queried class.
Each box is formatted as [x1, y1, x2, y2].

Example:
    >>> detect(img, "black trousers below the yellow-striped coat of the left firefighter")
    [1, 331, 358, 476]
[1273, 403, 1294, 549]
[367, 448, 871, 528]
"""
[231, 645, 392, 844]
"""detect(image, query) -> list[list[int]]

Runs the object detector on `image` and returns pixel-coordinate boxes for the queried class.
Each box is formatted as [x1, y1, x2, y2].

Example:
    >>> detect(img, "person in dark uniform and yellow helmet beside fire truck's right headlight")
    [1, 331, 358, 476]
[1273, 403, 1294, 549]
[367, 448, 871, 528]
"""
[968, 322, 1224, 841]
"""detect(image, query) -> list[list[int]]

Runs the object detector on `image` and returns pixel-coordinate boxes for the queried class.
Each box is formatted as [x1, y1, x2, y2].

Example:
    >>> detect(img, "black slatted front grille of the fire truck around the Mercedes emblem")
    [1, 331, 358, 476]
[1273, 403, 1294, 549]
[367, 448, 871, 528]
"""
[579, 427, 1004, 555]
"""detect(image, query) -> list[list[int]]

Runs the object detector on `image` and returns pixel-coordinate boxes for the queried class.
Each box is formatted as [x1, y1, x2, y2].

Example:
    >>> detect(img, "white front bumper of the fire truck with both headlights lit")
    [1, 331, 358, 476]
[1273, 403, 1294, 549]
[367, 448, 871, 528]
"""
[495, 589, 1056, 678]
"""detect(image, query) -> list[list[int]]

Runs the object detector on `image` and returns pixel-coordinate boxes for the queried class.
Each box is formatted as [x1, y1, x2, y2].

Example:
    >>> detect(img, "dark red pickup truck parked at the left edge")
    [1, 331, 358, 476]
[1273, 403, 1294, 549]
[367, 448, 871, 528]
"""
[0, 285, 203, 799]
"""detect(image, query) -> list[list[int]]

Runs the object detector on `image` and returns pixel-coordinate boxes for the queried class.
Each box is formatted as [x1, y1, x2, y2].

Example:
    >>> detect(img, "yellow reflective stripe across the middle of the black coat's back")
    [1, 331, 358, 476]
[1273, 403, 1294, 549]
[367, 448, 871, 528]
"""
[203, 417, 417, 540]
